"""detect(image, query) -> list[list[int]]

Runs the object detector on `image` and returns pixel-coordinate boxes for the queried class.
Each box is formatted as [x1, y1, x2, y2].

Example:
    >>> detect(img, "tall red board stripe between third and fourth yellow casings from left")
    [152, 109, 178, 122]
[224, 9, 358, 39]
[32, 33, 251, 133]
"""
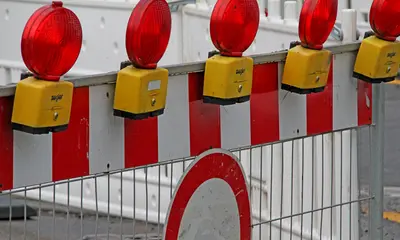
[250, 63, 279, 145]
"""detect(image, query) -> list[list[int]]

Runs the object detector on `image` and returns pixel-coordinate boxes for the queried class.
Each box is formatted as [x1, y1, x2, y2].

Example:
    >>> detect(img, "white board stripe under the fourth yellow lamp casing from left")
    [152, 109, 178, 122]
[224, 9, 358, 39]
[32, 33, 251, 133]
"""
[278, 63, 307, 139]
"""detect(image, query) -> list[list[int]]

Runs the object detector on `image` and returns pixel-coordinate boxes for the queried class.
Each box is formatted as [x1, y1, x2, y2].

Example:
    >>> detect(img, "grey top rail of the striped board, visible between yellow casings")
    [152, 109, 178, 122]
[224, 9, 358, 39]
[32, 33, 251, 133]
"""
[0, 42, 360, 97]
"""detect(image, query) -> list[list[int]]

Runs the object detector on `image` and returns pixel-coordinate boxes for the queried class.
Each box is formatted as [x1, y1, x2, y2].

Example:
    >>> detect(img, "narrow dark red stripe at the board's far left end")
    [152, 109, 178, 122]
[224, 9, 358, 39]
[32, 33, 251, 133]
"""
[0, 97, 14, 191]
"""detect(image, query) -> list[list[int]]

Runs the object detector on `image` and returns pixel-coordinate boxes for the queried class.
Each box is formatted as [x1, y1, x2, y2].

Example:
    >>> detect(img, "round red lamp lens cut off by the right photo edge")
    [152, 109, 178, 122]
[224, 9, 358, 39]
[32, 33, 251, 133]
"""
[369, 0, 400, 41]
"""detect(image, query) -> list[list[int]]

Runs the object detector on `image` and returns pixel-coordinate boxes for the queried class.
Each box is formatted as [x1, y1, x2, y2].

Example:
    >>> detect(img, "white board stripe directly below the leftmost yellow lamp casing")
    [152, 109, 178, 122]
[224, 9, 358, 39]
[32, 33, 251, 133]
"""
[13, 131, 53, 188]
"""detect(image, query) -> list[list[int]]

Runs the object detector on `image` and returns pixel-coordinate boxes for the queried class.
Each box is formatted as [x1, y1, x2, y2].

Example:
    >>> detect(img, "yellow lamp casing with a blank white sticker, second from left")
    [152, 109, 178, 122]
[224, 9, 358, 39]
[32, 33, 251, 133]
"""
[114, 65, 168, 119]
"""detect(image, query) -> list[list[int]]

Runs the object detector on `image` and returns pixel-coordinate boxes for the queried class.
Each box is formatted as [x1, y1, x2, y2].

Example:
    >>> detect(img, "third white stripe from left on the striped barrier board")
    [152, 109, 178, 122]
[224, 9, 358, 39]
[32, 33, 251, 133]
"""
[158, 75, 190, 161]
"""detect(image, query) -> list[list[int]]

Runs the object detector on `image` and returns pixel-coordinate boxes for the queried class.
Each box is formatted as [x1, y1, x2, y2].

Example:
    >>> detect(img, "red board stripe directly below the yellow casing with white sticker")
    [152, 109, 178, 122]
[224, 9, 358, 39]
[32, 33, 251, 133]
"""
[125, 117, 158, 168]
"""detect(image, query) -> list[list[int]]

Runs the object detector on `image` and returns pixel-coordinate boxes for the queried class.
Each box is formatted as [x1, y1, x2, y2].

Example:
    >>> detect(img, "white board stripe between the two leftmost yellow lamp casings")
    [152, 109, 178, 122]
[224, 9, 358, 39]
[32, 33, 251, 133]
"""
[89, 84, 125, 174]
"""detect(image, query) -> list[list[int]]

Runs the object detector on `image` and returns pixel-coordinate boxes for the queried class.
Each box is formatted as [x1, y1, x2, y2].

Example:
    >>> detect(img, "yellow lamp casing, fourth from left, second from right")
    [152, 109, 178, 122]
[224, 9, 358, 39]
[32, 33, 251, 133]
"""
[281, 45, 332, 94]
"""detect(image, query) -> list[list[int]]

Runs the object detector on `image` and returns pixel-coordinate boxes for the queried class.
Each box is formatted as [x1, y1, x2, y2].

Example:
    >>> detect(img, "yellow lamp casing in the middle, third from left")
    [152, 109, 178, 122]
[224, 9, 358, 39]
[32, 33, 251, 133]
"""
[203, 55, 253, 105]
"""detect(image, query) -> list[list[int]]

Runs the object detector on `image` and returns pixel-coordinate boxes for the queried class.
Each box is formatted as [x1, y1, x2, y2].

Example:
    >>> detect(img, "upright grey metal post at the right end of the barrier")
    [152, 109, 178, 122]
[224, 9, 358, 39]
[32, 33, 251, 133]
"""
[369, 83, 385, 240]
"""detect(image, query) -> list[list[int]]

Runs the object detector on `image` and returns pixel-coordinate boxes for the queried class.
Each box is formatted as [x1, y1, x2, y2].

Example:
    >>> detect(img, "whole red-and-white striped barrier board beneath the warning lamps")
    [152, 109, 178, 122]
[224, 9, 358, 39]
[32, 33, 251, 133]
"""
[0, 43, 372, 190]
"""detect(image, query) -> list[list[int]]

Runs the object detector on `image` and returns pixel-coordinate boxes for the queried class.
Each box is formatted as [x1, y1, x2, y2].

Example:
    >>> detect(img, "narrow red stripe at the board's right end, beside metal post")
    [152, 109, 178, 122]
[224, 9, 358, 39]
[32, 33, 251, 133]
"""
[357, 80, 372, 126]
